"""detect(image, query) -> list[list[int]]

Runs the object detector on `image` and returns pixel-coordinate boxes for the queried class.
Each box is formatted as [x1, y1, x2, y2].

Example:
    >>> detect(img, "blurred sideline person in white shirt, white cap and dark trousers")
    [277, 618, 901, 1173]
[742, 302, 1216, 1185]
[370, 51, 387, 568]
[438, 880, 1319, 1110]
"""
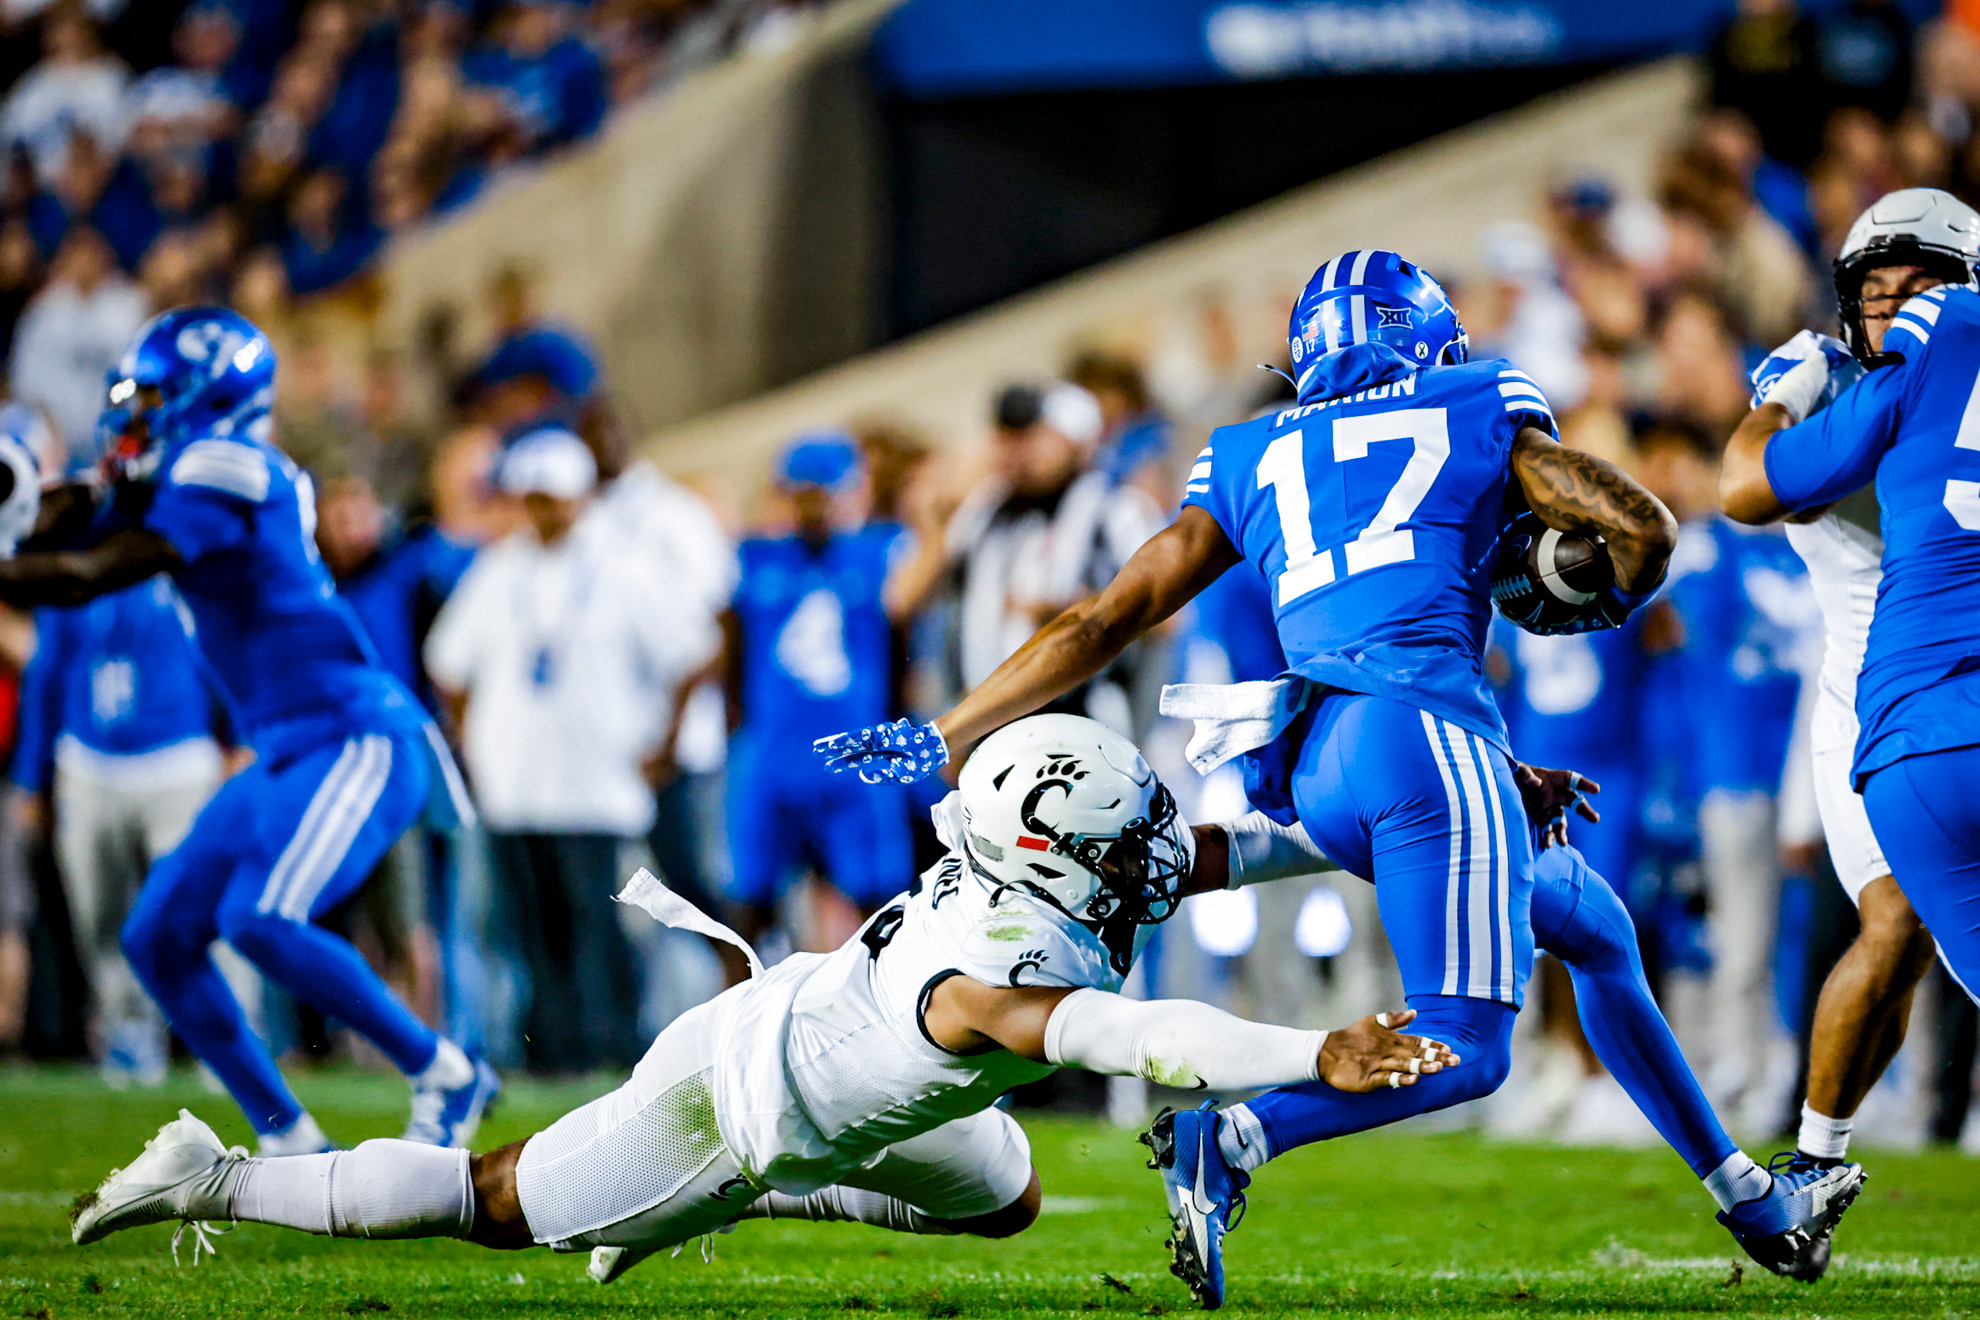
[426, 425, 715, 1073]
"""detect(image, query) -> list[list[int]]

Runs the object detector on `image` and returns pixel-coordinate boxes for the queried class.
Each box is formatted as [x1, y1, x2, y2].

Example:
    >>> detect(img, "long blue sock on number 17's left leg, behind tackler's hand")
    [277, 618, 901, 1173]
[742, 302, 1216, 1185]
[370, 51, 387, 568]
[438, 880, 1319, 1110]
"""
[1251, 995, 1513, 1156]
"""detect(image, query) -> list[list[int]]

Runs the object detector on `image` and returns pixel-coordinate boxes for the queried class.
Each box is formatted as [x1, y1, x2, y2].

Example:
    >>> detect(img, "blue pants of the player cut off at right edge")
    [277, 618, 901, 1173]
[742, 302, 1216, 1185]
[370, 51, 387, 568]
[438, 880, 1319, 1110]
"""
[1863, 746, 1980, 995]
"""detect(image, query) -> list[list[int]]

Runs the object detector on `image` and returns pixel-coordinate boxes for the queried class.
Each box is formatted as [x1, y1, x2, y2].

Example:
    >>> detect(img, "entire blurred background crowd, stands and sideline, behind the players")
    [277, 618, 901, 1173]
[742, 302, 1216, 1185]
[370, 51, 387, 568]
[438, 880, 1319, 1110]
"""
[0, 0, 1980, 1140]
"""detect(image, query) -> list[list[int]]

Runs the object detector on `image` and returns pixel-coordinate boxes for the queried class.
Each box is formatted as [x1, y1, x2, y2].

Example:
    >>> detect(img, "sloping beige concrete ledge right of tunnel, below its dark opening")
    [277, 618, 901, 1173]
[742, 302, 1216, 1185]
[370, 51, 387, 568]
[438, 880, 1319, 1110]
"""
[647, 57, 1701, 493]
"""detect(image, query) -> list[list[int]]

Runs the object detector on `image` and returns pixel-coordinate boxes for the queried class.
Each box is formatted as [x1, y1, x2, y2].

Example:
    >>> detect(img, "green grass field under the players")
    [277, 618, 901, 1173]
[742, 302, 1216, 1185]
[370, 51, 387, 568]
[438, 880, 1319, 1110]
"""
[0, 1069, 1980, 1320]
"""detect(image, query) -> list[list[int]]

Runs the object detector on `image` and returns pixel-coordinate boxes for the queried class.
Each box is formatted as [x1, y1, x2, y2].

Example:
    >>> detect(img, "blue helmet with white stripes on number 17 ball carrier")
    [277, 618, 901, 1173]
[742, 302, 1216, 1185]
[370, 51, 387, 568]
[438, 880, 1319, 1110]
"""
[1287, 249, 1471, 396]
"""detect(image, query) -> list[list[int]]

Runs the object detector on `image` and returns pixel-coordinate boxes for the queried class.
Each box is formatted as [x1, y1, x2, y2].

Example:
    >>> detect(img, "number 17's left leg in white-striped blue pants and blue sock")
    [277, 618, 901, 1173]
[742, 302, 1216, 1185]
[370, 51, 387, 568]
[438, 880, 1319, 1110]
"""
[1247, 693, 1533, 1154]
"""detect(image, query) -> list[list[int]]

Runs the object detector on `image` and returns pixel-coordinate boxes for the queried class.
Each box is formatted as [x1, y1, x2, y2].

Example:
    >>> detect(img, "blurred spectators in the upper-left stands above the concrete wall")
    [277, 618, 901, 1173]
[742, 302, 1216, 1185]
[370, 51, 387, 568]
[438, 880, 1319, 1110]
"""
[0, 0, 822, 484]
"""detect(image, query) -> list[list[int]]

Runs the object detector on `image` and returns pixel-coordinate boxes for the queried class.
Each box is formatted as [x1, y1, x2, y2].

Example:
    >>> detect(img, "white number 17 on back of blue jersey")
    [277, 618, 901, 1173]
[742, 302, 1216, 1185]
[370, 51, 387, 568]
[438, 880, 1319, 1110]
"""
[1257, 408, 1451, 610]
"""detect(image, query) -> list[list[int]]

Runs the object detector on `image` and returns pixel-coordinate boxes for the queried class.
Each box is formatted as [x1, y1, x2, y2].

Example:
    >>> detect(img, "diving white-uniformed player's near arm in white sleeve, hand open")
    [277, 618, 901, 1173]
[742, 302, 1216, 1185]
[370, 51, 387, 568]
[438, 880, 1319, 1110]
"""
[923, 976, 1459, 1092]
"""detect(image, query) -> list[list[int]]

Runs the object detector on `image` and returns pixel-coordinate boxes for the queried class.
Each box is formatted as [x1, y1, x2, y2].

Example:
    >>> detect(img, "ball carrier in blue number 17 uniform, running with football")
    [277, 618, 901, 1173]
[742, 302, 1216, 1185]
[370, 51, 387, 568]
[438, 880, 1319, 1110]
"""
[820, 251, 1861, 1306]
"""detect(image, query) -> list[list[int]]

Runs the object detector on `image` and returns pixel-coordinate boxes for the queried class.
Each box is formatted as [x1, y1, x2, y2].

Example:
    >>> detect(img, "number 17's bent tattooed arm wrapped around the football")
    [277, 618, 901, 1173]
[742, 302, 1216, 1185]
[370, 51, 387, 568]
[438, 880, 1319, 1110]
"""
[1513, 425, 1677, 596]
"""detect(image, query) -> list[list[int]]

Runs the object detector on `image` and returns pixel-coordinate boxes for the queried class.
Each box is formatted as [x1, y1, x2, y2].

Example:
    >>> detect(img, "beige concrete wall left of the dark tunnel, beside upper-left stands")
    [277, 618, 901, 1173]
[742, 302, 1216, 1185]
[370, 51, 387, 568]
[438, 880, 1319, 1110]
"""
[380, 0, 899, 429]
